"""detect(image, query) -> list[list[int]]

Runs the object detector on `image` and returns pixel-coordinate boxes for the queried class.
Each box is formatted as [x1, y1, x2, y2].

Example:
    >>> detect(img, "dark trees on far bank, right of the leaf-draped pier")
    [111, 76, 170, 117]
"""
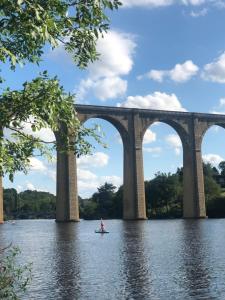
[80, 162, 225, 219]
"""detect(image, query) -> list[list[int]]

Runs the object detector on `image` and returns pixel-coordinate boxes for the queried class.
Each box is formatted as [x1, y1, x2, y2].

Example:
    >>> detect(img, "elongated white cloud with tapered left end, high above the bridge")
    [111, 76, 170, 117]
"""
[138, 60, 199, 83]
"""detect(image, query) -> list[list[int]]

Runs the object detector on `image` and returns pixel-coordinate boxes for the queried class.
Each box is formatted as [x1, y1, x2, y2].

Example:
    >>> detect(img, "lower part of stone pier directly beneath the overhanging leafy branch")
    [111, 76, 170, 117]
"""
[56, 144, 79, 222]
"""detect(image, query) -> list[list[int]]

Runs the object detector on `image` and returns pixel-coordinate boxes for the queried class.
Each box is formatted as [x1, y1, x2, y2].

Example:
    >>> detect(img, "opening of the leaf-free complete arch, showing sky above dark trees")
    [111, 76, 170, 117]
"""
[142, 120, 183, 218]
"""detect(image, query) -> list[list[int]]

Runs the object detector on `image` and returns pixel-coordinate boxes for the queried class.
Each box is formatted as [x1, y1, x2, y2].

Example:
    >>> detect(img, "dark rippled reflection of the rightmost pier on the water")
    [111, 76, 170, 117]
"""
[180, 220, 217, 299]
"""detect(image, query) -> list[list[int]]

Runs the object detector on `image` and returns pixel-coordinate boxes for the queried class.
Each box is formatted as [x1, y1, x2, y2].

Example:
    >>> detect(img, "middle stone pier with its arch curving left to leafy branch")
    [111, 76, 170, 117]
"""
[78, 113, 146, 219]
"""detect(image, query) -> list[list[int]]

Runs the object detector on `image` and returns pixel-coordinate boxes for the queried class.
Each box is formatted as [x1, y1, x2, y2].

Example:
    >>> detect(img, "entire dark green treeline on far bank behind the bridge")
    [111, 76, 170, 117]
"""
[4, 163, 225, 220]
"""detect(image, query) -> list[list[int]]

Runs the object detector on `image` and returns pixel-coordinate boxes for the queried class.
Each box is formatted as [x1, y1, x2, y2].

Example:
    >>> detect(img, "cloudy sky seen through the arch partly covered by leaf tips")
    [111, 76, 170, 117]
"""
[78, 116, 123, 204]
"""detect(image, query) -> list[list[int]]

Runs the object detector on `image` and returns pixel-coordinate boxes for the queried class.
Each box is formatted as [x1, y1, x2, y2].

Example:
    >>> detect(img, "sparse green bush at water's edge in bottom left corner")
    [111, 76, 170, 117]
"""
[0, 247, 31, 300]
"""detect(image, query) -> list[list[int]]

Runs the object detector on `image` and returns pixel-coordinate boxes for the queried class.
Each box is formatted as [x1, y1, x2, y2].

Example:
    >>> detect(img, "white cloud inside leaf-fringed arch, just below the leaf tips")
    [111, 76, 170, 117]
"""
[77, 152, 109, 168]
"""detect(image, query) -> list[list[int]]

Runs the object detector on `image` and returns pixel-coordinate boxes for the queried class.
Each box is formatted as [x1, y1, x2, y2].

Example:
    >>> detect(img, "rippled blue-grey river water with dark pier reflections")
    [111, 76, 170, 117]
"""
[0, 219, 225, 300]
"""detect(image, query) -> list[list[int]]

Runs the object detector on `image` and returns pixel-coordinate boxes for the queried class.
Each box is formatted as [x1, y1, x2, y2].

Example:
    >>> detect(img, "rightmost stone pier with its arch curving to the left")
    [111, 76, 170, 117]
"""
[142, 113, 206, 218]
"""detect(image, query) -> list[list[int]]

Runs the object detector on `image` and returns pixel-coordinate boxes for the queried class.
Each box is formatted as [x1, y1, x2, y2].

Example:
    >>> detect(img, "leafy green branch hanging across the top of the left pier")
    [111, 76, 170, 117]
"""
[0, 72, 104, 180]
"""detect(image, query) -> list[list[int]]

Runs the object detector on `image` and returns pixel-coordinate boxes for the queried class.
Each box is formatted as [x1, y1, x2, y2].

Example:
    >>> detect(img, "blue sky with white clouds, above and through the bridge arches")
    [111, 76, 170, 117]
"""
[2, 0, 225, 197]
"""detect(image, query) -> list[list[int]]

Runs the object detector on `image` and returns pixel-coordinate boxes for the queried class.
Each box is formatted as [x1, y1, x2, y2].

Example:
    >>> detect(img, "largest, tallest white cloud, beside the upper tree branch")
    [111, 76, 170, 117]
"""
[76, 30, 136, 101]
